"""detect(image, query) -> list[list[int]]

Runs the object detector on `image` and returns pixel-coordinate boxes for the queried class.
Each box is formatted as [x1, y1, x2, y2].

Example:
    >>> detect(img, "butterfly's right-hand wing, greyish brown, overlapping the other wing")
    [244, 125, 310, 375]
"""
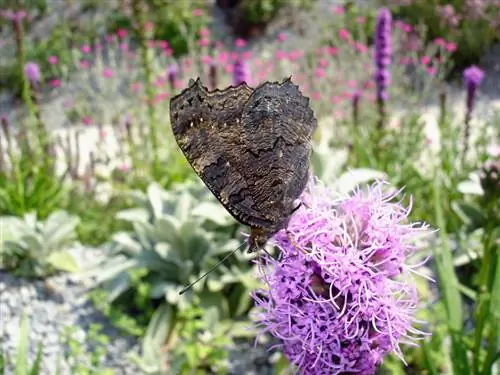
[241, 79, 317, 231]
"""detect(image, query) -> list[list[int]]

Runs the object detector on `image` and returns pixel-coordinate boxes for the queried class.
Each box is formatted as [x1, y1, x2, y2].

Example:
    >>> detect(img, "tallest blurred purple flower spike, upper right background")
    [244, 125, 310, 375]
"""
[374, 8, 392, 101]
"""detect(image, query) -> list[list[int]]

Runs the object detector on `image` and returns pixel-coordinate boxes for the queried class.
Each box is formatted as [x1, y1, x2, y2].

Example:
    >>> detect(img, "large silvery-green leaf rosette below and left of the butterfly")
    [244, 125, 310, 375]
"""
[90, 183, 256, 372]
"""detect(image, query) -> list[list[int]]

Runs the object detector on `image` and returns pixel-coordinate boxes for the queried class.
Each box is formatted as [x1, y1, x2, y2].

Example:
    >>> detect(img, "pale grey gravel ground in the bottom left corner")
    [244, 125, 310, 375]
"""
[0, 248, 138, 375]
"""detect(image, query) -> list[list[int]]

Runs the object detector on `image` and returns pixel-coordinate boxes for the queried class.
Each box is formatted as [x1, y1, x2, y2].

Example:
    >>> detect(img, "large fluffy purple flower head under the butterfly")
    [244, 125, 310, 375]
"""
[253, 181, 428, 375]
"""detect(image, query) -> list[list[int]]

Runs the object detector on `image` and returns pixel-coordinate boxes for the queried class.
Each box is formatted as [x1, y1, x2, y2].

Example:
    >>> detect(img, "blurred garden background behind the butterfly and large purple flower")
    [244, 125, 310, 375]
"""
[0, 0, 500, 375]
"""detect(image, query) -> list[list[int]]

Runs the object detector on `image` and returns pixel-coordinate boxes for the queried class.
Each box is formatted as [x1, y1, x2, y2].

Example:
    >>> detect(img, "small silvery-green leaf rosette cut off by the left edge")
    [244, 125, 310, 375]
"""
[0, 211, 80, 277]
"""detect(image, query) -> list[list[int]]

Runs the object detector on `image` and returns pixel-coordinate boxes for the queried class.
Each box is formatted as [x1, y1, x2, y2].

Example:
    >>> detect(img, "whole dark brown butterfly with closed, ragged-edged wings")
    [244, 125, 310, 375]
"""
[170, 78, 317, 252]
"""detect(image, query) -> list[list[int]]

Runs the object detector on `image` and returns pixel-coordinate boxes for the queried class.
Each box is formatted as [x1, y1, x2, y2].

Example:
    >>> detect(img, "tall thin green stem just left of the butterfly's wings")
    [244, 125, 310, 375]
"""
[132, 0, 159, 176]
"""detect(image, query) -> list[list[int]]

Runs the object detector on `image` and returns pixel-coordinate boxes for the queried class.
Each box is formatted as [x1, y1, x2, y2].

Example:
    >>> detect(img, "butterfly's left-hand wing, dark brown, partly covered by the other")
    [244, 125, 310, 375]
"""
[170, 79, 276, 227]
